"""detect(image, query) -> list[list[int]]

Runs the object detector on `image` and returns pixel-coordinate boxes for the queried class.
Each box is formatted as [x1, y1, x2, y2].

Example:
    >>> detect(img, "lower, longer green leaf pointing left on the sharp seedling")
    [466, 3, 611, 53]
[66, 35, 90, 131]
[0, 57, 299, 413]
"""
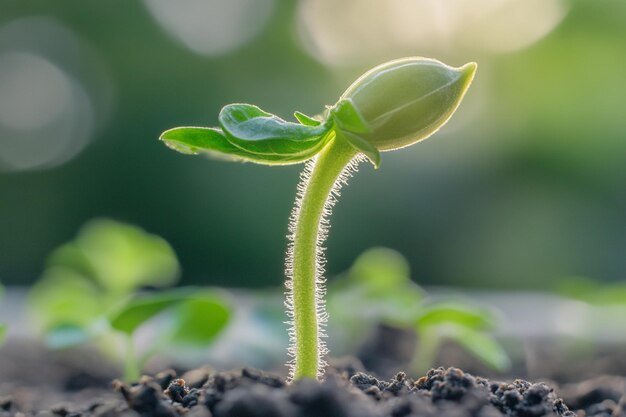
[160, 127, 330, 165]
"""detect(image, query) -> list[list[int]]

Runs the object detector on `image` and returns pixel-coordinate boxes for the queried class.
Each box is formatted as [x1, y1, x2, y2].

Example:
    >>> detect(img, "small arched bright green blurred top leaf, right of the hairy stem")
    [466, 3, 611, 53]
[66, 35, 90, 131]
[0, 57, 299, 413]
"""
[415, 303, 494, 330]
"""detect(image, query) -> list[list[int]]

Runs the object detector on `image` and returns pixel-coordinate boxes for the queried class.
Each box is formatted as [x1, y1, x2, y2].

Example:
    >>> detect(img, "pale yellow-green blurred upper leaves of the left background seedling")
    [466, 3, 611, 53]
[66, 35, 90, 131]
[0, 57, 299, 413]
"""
[29, 219, 179, 331]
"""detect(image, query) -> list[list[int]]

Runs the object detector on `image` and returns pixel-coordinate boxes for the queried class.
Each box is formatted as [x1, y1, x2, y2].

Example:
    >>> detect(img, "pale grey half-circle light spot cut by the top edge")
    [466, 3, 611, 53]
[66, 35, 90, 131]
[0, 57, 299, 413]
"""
[144, 0, 274, 55]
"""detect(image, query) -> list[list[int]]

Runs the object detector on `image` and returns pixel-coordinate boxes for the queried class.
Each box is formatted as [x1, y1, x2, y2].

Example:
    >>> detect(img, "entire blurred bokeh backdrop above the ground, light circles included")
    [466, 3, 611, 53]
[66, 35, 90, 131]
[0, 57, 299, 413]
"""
[0, 0, 626, 289]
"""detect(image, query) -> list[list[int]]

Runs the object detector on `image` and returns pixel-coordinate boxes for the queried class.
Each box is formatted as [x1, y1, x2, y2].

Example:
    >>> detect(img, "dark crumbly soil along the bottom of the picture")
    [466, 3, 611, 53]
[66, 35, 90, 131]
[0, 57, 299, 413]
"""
[0, 359, 626, 417]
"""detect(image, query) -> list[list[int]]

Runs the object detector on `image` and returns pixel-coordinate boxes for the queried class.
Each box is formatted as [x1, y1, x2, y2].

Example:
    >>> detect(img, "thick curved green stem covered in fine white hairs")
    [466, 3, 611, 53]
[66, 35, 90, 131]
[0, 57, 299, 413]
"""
[287, 139, 357, 379]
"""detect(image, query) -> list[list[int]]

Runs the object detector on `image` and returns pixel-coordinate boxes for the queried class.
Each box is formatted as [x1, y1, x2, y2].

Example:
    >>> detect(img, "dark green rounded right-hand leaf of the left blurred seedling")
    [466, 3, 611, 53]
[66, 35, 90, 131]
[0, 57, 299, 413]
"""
[172, 295, 231, 346]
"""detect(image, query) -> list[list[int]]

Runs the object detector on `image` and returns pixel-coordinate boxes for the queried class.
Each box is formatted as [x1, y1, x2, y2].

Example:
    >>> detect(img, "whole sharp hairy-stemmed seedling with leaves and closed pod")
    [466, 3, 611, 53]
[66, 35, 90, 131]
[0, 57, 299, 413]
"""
[160, 58, 476, 379]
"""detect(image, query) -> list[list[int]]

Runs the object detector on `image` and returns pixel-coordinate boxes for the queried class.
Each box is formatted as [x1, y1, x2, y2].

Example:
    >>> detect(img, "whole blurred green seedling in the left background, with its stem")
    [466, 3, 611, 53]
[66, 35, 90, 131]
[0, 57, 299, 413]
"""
[28, 219, 231, 381]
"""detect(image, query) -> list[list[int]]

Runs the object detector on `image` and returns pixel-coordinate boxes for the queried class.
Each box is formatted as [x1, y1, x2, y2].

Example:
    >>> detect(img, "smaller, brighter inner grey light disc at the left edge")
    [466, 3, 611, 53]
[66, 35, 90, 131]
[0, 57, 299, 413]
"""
[0, 52, 93, 170]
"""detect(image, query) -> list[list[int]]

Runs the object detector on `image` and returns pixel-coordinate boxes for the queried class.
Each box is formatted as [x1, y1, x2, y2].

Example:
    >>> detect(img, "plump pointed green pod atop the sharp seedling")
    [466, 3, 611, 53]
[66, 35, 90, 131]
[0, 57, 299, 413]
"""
[339, 57, 476, 151]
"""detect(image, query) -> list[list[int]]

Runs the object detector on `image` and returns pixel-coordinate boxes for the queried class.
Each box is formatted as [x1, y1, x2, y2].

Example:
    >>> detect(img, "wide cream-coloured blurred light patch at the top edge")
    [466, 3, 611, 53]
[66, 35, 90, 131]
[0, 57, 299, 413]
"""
[298, 0, 568, 65]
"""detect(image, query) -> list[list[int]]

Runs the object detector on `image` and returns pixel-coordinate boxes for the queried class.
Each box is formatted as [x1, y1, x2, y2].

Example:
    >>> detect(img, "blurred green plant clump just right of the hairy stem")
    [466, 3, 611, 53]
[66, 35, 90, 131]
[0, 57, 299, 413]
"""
[329, 247, 510, 374]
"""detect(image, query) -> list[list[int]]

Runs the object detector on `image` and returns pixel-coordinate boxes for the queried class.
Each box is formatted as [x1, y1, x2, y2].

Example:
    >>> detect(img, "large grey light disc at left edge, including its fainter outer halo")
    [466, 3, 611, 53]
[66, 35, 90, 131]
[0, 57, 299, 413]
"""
[0, 17, 112, 171]
